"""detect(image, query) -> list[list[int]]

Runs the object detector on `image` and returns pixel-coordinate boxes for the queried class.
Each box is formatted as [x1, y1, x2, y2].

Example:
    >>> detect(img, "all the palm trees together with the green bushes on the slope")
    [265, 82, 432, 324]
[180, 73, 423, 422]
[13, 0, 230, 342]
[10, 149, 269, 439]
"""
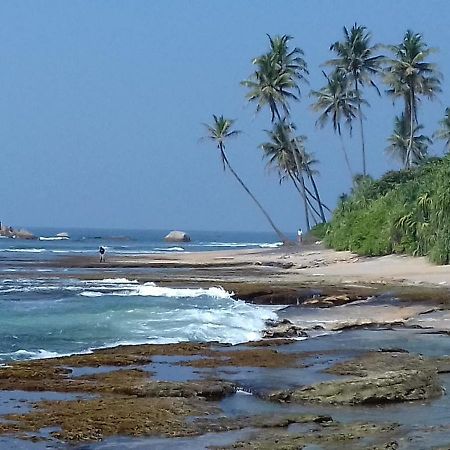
[207, 23, 450, 253]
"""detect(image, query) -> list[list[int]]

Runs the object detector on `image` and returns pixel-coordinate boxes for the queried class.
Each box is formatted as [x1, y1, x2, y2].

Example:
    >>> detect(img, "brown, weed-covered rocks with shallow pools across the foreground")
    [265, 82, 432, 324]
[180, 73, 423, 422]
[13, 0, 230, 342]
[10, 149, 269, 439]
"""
[0, 339, 450, 449]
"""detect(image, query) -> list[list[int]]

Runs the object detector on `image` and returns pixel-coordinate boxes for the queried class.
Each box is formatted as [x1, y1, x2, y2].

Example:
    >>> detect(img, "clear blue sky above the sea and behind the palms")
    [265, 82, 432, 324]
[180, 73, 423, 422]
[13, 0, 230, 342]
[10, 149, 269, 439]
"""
[0, 0, 450, 232]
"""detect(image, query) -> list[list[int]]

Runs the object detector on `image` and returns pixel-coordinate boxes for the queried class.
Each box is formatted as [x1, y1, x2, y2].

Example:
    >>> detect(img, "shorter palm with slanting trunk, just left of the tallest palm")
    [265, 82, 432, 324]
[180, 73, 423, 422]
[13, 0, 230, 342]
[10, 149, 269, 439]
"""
[311, 70, 364, 179]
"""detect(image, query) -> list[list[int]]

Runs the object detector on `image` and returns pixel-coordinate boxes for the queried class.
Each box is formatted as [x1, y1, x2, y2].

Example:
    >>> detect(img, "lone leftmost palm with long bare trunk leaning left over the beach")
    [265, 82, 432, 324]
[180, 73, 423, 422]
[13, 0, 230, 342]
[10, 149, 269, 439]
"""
[204, 115, 288, 242]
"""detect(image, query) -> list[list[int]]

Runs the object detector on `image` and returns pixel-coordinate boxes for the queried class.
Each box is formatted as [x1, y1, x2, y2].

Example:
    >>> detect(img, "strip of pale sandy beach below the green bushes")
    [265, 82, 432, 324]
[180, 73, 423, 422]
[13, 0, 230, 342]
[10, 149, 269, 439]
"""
[61, 243, 450, 287]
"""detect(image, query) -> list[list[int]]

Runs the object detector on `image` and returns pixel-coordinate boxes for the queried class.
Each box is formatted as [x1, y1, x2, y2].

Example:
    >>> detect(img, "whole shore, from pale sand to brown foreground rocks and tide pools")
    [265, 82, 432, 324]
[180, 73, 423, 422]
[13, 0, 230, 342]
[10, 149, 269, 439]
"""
[0, 244, 450, 449]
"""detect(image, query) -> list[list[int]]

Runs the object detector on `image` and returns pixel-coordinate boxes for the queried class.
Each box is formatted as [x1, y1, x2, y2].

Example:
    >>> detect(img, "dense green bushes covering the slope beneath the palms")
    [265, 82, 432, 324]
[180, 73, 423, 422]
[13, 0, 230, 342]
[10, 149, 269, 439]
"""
[318, 155, 450, 264]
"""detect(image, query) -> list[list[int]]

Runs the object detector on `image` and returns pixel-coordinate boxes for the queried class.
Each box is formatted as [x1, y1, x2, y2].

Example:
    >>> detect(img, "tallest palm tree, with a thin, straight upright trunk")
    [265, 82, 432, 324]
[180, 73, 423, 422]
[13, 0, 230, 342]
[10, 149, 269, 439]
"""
[326, 23, 384, 175]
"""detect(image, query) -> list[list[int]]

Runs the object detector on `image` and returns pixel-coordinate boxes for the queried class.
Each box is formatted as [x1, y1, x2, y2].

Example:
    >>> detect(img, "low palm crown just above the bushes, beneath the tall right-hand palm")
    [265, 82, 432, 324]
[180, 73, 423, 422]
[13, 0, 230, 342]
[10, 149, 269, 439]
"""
[385, 113, 431, 169]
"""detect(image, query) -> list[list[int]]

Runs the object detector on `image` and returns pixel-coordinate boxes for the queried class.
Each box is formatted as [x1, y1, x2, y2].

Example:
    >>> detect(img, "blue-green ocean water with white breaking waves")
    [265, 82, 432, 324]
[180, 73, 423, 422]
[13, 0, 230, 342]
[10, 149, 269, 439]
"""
[0, 228, 280, 363]
